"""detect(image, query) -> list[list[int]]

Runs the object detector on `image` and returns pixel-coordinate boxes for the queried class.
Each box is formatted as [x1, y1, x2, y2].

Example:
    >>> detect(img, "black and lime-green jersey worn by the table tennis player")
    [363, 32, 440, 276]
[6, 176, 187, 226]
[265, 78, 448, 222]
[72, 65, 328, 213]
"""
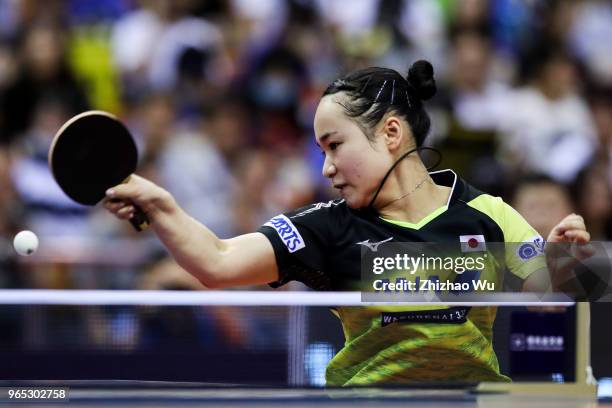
[259, 170, 545, 386]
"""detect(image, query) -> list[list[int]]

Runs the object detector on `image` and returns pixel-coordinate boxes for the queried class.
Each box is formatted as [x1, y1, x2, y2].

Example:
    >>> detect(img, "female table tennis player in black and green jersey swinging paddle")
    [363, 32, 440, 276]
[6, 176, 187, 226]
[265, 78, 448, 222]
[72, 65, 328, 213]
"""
[105, 61, 590, 386]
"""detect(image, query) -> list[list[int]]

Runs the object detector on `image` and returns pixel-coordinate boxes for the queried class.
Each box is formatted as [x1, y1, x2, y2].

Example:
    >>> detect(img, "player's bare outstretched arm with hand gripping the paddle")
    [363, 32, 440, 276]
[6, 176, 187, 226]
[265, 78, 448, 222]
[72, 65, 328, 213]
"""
[104, 175, 278, 288]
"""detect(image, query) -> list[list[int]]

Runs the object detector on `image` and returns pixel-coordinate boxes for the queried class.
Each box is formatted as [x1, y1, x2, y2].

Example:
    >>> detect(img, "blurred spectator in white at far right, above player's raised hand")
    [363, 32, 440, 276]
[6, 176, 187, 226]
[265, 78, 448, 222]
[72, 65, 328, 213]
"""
[500, 51, 597, 183]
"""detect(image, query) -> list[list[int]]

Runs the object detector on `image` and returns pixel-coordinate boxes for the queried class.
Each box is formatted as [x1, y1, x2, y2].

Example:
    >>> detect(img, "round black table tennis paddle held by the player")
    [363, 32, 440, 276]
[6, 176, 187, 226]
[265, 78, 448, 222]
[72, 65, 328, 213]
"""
[49, 111, 149, 231]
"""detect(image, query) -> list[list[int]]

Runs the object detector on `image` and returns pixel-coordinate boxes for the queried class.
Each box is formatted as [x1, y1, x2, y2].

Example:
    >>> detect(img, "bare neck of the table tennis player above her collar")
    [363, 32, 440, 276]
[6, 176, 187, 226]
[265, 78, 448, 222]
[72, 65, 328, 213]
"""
[377, 159, 451, 224]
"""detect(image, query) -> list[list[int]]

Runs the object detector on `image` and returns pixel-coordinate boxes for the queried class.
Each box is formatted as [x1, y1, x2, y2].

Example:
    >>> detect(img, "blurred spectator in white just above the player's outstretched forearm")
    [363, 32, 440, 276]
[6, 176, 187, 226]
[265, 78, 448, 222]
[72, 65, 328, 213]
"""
[157, 96, 244, 236]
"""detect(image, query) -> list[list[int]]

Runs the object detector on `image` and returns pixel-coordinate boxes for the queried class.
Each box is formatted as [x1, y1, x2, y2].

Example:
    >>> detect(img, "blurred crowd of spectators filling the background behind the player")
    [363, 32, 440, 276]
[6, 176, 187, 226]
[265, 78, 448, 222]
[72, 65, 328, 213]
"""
[0, 0, 612, 289]
